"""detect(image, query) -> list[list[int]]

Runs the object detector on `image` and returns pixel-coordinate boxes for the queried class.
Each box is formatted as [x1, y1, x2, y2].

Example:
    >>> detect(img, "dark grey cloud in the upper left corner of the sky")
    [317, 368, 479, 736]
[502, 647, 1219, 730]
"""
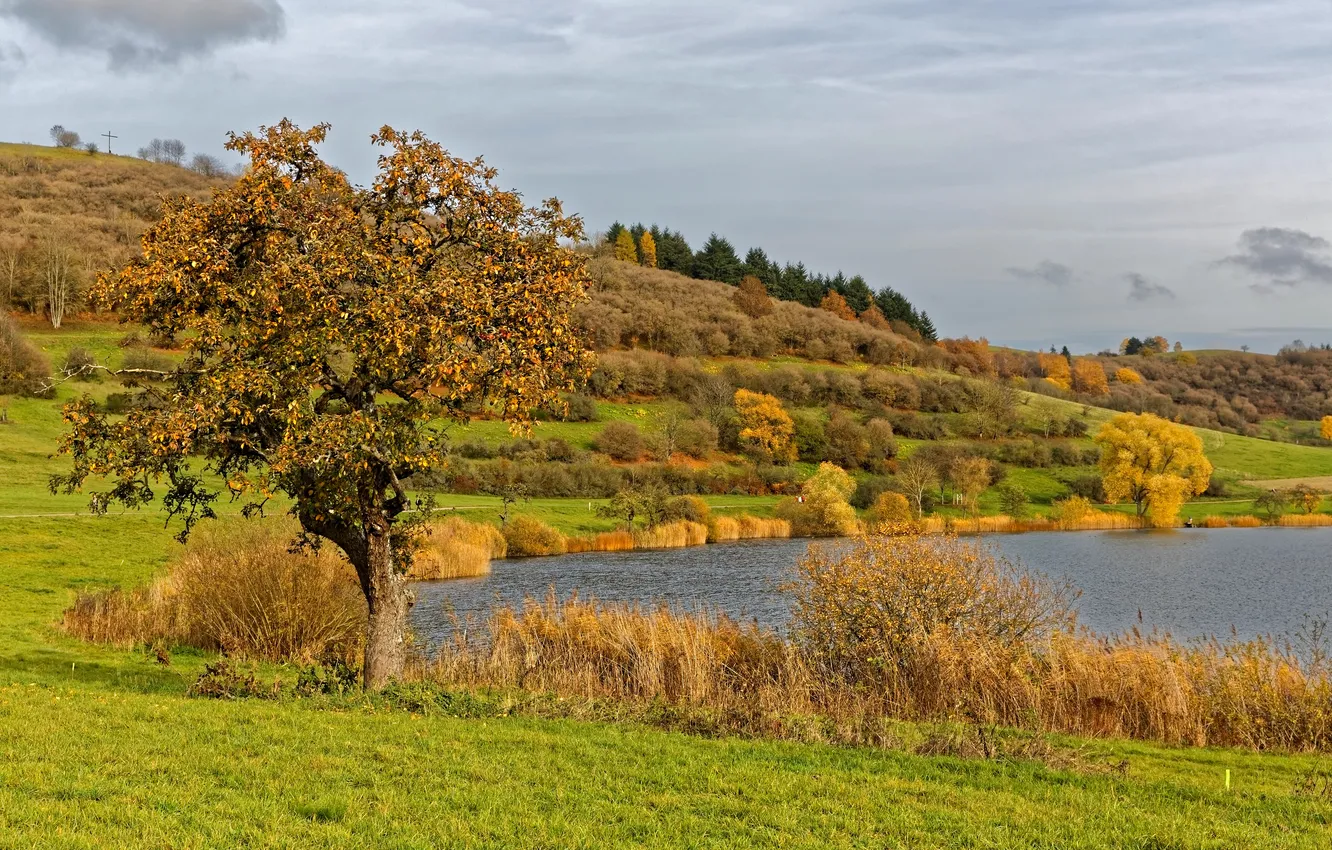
[0, 0, 286, 69]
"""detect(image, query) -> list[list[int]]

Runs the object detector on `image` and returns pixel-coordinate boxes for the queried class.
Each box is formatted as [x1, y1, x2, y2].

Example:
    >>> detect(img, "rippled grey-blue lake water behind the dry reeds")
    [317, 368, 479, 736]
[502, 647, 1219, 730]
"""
[413, 529, 1332, 643]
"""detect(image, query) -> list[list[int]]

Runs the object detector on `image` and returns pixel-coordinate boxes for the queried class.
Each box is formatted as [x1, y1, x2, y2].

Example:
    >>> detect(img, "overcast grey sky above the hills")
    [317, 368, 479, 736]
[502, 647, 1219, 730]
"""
[0, 0, 1332, 352]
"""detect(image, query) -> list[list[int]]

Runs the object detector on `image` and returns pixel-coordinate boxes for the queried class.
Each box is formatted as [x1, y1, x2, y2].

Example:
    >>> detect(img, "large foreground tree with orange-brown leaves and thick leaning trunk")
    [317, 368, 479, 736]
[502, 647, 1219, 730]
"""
[51, 120, 589, 687]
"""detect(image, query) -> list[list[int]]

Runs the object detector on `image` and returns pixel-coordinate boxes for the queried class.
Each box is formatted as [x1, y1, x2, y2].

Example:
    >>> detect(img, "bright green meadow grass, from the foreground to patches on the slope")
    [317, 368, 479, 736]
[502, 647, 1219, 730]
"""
[0, 324, 1332, 850]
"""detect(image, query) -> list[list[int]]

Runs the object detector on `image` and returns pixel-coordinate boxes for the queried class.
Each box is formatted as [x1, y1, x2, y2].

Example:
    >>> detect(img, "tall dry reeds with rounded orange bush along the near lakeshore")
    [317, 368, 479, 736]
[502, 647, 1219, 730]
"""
[428, 536, 1332, 751]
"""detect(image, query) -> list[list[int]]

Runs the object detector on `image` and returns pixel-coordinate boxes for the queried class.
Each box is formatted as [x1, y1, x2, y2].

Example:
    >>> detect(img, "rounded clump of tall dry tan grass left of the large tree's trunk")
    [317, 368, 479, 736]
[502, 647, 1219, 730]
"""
[63, 525, 366, 662]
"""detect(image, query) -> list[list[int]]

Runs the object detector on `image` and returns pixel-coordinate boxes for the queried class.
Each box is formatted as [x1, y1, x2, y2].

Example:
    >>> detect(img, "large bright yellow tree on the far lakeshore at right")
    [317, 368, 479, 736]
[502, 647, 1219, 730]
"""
[1096, 413, 1212, 528]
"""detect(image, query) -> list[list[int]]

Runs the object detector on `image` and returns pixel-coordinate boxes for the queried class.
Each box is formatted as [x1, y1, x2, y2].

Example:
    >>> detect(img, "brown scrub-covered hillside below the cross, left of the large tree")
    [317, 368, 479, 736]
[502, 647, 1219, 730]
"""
[0, 144, 224, 313]
